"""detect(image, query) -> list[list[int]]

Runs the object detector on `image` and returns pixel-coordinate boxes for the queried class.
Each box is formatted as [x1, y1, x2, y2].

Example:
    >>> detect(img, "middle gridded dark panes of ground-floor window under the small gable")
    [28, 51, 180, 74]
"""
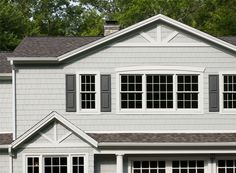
[44, 156, 67, 173]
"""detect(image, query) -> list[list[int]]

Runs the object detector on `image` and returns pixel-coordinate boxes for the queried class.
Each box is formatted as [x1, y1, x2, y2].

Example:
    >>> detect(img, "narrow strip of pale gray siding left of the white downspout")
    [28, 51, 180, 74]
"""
[0, 80, 12, 132]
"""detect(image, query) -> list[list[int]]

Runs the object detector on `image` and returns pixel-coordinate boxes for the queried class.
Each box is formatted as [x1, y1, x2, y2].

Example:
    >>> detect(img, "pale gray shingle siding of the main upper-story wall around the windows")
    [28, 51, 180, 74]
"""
[13, 25, 236, 135]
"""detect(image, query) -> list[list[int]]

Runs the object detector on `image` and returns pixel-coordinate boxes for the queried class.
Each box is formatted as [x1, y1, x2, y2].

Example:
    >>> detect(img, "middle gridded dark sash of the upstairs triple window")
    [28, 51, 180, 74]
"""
[146, 74, 173, 109]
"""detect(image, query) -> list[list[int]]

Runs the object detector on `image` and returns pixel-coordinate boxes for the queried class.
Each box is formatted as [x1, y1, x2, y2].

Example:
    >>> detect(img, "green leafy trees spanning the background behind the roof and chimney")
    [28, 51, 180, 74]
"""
[0, 0, 236, 50]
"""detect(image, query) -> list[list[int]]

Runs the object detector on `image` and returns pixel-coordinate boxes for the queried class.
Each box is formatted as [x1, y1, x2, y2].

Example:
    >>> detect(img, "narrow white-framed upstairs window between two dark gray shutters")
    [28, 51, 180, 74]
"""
[78, 73, 99, 113]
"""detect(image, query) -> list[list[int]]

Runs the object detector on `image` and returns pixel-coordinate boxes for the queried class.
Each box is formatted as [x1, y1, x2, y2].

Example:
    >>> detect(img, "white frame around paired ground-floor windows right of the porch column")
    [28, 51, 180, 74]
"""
[128, 156, 211, 173]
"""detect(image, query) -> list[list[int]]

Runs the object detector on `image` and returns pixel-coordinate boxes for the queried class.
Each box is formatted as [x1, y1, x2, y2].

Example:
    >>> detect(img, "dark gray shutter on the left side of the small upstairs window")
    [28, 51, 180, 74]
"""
[66, 74, 76, 112]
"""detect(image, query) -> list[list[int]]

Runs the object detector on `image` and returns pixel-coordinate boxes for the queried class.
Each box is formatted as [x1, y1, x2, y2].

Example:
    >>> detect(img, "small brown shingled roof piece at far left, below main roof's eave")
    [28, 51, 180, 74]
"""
[0, 52, 12, 73]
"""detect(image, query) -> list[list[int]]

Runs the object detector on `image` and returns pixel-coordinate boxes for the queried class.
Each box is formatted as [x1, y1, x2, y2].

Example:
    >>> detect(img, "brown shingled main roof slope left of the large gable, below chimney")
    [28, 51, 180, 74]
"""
[13, 37, 101, 57]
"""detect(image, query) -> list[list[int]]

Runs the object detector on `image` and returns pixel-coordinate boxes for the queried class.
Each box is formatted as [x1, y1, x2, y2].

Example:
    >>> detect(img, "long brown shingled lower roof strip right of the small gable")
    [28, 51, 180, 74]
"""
[88, 133, 236, 143]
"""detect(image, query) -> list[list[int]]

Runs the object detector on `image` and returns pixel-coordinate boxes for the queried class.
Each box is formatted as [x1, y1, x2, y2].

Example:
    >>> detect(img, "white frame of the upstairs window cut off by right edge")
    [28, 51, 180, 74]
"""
[219, 71, 236, 114]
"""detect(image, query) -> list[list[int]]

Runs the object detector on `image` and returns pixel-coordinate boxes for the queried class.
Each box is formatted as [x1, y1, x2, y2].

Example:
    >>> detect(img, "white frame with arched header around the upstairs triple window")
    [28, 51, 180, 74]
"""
[116, 66, 204, 114]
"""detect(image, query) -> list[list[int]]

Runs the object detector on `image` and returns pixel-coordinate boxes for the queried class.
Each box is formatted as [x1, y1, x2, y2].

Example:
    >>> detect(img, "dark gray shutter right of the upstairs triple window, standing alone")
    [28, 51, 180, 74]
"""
[209, 75, 219, 112]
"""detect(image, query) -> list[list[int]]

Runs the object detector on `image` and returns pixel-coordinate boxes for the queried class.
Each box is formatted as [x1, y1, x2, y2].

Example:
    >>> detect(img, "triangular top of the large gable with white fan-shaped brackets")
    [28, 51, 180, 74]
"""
[113, 24, 208, 46]
